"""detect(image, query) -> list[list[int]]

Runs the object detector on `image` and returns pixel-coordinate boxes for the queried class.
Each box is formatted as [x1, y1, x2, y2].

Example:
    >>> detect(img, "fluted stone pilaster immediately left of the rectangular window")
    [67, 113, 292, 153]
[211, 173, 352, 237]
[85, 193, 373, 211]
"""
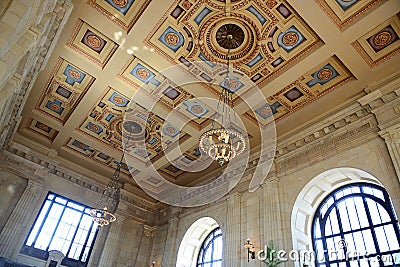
[0, 180, 47, 260]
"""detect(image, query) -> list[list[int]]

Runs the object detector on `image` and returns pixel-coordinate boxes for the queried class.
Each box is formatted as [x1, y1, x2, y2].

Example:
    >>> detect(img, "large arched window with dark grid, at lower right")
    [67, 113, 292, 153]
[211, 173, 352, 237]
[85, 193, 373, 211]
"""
[312, 183, 400, 267]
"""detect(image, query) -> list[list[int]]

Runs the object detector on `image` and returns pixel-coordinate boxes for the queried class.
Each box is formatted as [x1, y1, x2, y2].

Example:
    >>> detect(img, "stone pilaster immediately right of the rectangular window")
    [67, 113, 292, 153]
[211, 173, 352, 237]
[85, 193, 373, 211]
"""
[98, 214, 125, 267]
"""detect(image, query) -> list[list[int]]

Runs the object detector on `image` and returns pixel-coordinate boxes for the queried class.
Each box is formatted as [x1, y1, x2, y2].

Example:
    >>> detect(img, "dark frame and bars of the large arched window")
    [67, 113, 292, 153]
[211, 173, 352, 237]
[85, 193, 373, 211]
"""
[311, 183, 400, 267]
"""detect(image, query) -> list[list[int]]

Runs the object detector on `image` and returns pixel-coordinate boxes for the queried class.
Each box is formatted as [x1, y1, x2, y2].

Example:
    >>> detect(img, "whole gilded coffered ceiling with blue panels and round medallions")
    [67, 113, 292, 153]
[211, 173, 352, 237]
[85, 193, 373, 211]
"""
[15, 0, 400, 205]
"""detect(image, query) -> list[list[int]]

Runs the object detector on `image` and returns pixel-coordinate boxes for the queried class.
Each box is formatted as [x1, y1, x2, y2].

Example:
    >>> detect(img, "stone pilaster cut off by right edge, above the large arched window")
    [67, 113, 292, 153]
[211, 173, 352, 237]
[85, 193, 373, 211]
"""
[379, 124, 400, 181]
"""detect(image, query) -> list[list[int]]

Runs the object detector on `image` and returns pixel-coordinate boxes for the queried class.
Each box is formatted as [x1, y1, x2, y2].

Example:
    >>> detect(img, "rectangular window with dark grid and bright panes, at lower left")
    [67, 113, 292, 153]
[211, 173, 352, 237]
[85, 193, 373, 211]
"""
[21, 193, 98, 266]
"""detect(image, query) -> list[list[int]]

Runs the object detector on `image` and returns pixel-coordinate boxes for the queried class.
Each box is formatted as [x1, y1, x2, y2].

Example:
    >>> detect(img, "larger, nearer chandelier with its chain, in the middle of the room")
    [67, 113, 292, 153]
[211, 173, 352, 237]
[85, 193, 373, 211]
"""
[199, 35, 246, 166]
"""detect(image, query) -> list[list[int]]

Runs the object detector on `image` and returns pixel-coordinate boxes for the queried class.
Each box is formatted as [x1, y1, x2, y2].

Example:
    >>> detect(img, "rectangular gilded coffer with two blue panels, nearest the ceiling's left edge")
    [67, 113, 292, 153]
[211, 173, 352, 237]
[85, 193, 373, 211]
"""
[35, 58, 95, 124]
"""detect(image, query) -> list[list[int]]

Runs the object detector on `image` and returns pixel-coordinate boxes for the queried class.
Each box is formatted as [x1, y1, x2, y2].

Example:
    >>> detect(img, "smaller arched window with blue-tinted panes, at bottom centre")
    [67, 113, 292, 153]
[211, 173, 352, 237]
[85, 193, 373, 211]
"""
[196, 227, 222, 267]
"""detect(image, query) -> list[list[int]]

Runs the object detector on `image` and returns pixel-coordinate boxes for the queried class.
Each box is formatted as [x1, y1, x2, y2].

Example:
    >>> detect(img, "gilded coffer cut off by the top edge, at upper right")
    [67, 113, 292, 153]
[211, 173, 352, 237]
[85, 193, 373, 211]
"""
[315, 0, 385, 29]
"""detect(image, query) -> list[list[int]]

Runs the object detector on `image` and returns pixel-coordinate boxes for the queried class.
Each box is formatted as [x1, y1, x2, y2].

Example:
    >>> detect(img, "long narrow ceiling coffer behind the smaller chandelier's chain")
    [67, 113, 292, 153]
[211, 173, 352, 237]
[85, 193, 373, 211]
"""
[64, 138, 137, 175]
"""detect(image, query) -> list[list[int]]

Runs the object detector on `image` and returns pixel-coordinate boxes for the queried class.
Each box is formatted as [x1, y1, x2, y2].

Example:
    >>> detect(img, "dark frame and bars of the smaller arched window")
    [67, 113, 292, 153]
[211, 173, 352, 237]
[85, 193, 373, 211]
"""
[196, 227, 223, 267]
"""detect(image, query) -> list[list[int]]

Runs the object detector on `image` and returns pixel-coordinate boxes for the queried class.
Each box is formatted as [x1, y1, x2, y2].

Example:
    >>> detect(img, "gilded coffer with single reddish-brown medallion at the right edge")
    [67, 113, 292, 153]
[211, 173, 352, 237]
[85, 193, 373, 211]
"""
[352, 13, 400, 67]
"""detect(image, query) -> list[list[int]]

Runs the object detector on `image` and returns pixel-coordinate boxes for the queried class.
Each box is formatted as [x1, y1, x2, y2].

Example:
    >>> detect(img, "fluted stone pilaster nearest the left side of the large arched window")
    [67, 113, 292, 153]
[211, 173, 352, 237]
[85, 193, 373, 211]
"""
[263, 175, 283, 248]
